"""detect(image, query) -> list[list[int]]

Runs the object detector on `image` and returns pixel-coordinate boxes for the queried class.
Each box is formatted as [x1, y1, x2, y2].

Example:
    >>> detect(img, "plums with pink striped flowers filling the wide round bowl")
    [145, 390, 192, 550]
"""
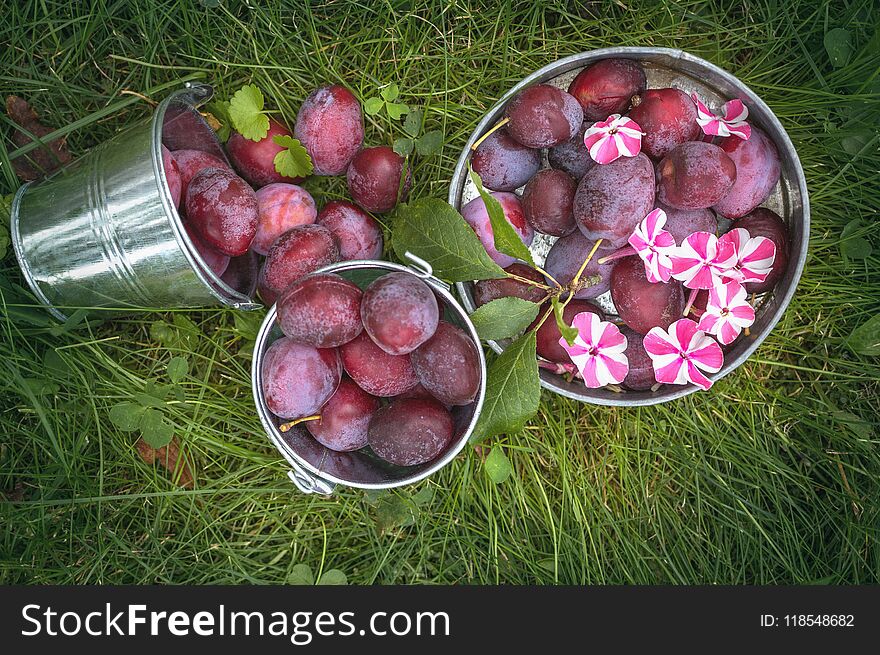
[450, 48, 809, 404]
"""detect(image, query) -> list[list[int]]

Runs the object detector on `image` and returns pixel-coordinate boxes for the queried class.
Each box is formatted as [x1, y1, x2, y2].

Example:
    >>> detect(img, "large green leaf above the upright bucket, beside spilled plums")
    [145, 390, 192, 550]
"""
[392, 198, 507, 282]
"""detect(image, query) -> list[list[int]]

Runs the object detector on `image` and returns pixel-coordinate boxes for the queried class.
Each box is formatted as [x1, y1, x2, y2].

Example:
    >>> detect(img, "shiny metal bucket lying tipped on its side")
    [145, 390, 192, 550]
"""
[11, 84, 260, 320]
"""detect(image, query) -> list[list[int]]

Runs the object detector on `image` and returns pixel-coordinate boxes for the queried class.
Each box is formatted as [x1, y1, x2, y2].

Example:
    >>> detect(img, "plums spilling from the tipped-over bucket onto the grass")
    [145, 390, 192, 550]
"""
[163, 85, 411, 305]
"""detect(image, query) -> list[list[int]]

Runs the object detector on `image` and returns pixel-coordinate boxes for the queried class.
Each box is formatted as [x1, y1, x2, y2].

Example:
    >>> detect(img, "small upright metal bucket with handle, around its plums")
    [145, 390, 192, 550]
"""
[251, 256, 486, 494]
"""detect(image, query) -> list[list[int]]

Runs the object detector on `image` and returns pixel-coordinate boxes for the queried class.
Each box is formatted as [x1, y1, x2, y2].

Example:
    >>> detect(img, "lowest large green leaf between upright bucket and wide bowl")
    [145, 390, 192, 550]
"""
[471, 331, 541, 442]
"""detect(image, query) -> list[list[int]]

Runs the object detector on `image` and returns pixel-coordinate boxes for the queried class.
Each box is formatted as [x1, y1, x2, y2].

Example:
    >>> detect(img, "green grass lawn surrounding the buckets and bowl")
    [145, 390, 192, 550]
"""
[0, 0, 880, 584]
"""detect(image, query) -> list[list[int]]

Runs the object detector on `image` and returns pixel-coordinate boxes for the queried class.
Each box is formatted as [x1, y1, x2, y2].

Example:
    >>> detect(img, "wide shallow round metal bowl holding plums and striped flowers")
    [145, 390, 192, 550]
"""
[449, 48, 810, 405]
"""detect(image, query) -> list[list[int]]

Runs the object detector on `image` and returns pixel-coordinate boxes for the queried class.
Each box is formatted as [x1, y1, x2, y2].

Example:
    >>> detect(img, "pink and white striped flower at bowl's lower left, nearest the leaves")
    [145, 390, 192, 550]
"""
[559, 312, 629, 389]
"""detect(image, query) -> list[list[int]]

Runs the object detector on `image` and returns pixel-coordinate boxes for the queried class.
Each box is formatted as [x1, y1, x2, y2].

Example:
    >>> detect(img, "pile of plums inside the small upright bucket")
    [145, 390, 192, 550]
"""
[254, 262, 485, 472]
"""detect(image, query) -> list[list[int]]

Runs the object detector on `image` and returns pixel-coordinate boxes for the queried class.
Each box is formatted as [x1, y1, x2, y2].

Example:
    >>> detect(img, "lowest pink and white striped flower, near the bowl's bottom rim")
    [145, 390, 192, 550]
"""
[642, 318, 724, 390]
